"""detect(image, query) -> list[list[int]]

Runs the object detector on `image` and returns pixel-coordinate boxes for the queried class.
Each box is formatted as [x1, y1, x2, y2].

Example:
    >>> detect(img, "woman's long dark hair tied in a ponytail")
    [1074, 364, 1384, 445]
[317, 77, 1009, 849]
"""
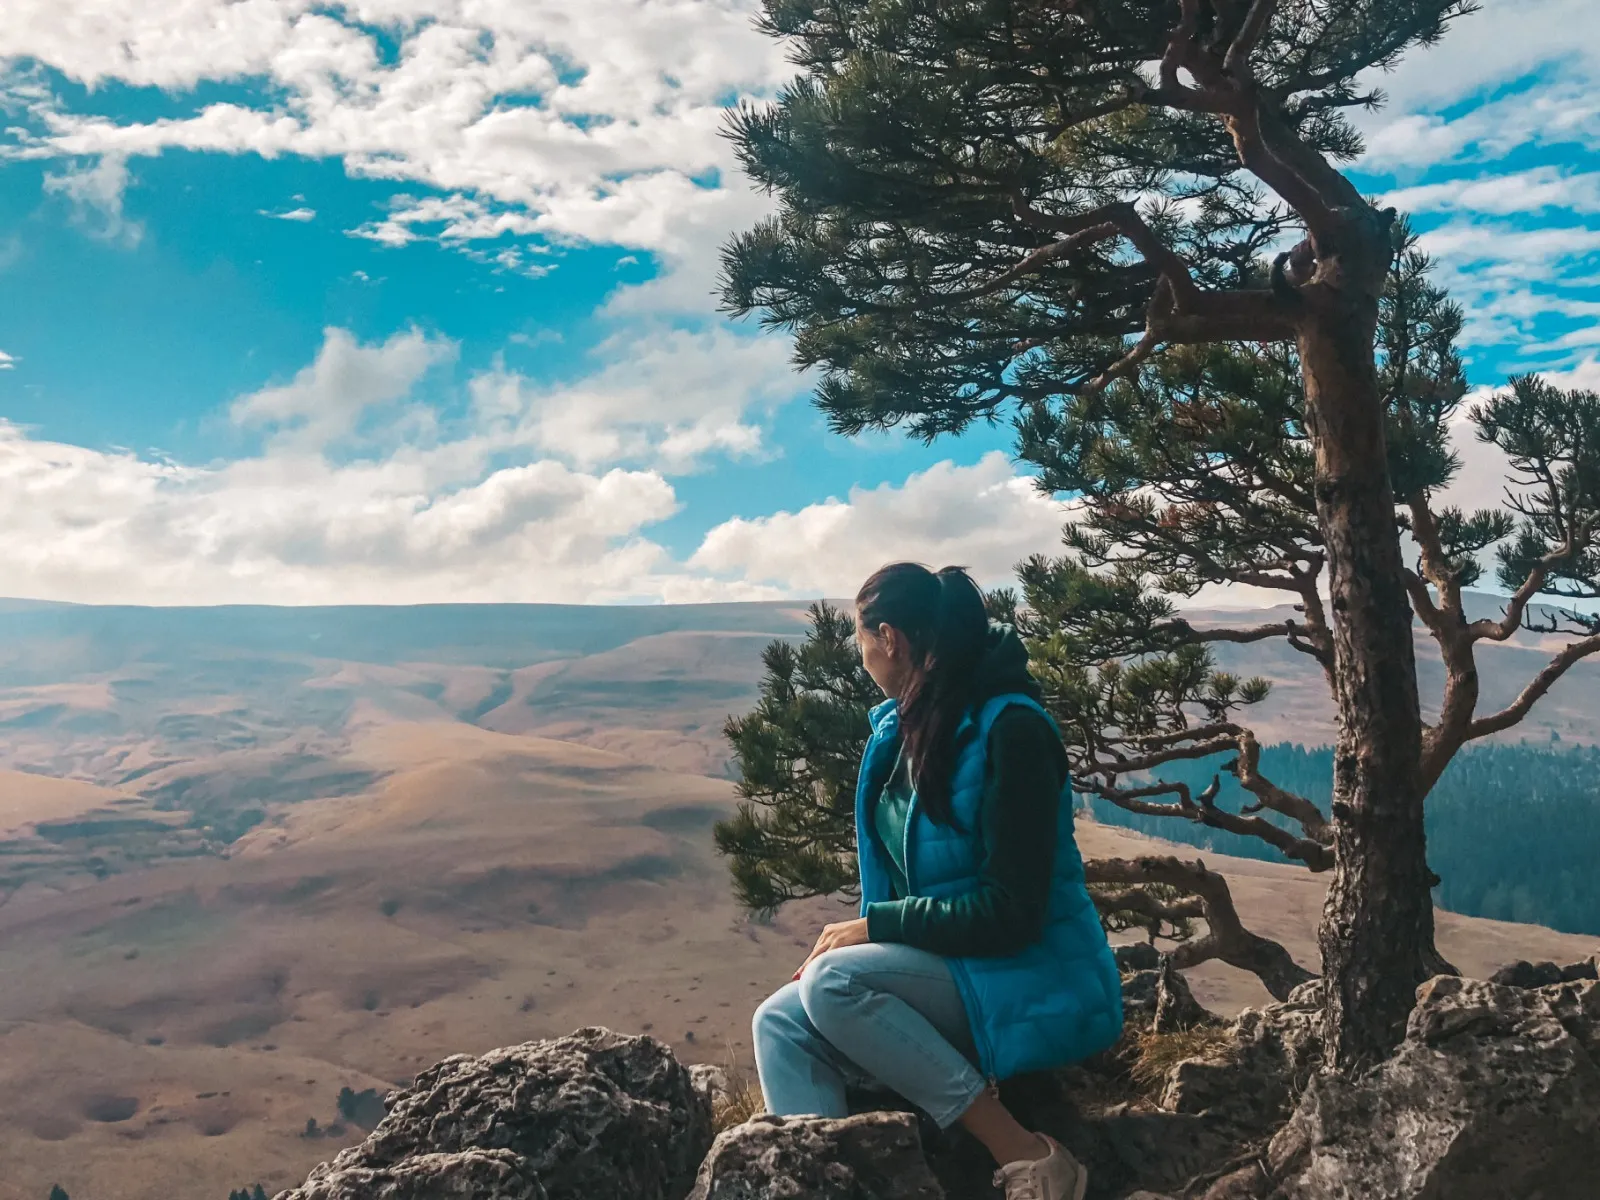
[856, 563, 989, 824]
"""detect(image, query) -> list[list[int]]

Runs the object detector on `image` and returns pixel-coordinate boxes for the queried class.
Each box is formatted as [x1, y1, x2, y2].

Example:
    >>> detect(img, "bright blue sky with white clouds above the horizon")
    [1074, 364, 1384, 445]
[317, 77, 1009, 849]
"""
[0, 0, 1600, 603]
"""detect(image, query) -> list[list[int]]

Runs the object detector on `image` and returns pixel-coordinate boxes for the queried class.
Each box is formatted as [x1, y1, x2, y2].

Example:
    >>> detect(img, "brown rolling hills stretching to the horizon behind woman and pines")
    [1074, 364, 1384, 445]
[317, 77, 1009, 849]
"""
[0, 602, 1600, 1200]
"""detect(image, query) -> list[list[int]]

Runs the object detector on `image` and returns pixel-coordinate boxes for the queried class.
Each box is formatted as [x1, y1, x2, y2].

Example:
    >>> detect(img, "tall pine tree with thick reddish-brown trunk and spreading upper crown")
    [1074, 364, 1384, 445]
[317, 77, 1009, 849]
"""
[723, 0, 1589, 1069]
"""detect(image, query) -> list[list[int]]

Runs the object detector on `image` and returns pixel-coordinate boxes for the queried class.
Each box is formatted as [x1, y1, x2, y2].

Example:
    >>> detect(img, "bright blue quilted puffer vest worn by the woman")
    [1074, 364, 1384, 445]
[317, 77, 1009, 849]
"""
[856, 693, 1122, 1080]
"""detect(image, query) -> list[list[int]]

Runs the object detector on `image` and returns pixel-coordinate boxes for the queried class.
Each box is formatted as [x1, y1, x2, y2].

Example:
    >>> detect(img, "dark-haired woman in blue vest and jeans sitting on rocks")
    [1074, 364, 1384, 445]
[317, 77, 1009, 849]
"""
[754, 563, 1122, 1200]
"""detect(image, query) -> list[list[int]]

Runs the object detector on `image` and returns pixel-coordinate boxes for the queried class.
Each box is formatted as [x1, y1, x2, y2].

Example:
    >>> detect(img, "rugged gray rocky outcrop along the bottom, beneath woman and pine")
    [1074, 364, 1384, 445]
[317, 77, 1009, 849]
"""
[280, 963, 1600, 1200]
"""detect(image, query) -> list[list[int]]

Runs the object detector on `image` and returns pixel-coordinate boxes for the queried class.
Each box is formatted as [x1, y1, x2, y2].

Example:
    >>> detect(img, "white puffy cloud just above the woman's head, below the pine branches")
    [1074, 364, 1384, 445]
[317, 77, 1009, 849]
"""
[688, 453, 1067, 595]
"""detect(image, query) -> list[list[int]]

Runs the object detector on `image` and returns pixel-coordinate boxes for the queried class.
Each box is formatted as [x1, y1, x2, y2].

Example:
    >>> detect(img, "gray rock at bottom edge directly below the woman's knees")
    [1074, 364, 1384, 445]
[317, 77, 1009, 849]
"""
[681, 1112, 944, 1200]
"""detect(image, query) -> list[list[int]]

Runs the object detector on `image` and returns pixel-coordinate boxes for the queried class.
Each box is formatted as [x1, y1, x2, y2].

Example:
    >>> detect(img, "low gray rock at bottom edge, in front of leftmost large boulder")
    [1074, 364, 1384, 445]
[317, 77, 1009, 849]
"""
[278, 1150, 546, 1200]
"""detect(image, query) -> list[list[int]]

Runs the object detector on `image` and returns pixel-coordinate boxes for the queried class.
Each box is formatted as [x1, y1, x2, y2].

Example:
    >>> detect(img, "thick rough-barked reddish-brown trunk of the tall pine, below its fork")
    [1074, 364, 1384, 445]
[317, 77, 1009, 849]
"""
[1299, 260, 1440, 1070]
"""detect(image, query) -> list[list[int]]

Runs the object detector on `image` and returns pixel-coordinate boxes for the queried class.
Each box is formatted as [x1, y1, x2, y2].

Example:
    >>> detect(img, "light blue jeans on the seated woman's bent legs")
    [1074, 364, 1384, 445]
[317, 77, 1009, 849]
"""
[752, 942, 987, 1130]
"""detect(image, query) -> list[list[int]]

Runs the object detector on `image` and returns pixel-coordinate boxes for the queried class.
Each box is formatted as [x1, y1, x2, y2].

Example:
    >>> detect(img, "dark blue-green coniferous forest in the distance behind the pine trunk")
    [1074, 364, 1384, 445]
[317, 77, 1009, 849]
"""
[1080, 744, 1600, 933]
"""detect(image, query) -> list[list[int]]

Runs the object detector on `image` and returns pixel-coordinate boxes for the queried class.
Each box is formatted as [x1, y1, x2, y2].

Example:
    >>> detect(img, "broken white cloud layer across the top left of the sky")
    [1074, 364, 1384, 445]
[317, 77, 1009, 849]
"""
[0, 0, 790, 299]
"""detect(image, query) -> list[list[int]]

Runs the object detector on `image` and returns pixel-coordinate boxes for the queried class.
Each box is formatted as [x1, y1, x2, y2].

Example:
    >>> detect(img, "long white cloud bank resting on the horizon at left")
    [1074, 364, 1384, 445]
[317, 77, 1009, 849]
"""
[0, 320, 812, 603]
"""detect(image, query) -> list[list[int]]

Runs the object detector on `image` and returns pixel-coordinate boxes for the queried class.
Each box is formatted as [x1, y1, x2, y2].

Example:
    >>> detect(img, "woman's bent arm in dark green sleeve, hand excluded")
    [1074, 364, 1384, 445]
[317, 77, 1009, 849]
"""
[867, 707, 1070, 958]
